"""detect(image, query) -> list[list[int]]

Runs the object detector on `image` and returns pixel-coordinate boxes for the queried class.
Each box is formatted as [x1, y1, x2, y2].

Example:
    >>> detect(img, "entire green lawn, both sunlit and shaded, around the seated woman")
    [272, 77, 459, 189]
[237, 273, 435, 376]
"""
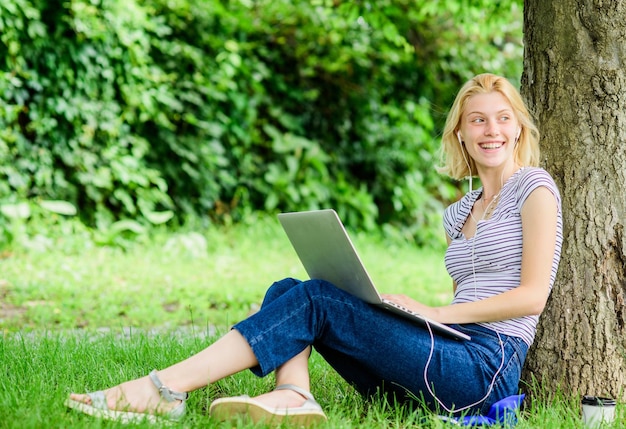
[0, 220, 623, 429]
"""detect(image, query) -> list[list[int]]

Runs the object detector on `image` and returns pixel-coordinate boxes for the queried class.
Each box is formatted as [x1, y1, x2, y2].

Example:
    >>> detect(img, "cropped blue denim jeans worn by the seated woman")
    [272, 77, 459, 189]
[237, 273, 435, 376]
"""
[233, 278, 528, 414]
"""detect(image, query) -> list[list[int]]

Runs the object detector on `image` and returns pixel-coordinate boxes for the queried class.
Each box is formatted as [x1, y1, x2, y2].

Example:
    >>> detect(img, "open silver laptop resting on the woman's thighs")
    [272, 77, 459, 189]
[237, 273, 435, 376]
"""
[278, 209, 471, 340]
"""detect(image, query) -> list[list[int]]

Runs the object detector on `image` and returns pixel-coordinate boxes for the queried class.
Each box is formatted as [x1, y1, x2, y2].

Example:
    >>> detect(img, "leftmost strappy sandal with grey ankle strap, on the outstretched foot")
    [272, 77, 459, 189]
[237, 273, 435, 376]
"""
[65, 370, 189, 423]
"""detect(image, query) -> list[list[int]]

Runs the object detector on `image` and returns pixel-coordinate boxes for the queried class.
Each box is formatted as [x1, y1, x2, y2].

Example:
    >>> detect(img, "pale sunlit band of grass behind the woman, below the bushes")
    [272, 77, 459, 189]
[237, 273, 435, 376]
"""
[0, 220, 451, 332]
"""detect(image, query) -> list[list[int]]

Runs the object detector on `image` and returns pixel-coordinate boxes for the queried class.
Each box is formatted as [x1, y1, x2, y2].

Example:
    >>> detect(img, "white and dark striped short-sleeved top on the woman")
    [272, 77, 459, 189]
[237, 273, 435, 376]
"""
[443, 167, 563, 346]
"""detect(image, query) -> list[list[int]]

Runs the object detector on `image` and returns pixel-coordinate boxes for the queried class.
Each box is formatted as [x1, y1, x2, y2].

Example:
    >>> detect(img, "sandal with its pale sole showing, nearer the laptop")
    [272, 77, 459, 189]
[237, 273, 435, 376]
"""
[209, 384, 327, 426]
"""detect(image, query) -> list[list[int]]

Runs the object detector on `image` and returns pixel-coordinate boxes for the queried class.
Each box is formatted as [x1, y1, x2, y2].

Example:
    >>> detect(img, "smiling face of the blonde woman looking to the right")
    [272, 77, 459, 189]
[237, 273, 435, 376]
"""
[459, 91, 520, 171]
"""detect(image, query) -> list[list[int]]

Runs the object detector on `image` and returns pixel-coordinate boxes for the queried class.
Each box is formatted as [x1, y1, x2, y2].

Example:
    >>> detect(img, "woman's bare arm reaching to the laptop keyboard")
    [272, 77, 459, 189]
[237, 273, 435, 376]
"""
[385, 187, 557, 323]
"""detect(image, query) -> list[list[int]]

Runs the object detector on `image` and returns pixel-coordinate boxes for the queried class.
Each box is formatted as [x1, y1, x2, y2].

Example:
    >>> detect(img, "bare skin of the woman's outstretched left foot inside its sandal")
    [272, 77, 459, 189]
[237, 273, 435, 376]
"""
[70, 377, 181, 414]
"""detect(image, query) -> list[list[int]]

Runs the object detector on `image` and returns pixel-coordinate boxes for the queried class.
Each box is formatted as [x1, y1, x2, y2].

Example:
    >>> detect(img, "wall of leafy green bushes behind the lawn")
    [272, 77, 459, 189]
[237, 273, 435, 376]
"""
[0, 0, 522, 244]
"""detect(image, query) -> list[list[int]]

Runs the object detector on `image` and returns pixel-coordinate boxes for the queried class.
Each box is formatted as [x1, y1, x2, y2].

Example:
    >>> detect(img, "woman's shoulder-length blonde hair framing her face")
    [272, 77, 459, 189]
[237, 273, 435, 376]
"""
[439, 73, 539, 180]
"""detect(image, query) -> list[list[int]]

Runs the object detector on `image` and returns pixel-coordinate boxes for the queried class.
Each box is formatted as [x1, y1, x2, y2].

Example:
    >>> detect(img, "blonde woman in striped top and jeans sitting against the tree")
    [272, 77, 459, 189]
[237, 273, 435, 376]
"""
[67, 74, 562, 424]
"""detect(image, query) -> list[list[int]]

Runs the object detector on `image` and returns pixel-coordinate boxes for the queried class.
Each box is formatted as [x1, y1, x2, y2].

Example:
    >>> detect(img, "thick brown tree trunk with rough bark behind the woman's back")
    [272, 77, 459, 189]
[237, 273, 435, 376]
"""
[522, 0, 626, 400]
